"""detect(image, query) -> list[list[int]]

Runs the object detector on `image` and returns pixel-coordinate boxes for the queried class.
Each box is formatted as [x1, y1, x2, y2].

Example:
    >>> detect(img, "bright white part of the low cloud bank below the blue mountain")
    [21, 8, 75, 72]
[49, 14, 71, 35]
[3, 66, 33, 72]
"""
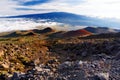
[0, 18, 63, 32]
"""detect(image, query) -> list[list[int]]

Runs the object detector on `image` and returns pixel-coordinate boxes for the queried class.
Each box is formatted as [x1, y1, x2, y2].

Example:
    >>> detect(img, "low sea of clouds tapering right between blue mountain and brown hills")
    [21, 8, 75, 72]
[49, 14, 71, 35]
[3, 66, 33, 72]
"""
[0, 18, 84, 32]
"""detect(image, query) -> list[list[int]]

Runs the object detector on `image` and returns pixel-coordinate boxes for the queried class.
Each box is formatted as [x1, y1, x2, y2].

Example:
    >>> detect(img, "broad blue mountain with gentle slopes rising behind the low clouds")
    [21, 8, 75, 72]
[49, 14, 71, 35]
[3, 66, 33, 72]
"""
[7, 12, 120, 27]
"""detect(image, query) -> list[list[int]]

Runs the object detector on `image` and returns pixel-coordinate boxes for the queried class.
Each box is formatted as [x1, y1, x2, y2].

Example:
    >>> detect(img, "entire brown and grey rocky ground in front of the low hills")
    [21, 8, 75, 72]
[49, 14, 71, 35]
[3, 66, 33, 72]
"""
[0, 29, 120, 80]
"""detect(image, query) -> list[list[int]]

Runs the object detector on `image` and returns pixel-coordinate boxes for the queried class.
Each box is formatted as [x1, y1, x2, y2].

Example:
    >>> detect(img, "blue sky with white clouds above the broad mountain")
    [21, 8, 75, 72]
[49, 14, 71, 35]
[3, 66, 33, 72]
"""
[0, 0, 120, 19]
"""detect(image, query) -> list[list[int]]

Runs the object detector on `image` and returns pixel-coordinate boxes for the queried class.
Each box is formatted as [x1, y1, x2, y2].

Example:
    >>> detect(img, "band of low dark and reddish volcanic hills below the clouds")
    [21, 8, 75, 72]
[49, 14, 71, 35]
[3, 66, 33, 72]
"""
[0, 27, 120, 39]
